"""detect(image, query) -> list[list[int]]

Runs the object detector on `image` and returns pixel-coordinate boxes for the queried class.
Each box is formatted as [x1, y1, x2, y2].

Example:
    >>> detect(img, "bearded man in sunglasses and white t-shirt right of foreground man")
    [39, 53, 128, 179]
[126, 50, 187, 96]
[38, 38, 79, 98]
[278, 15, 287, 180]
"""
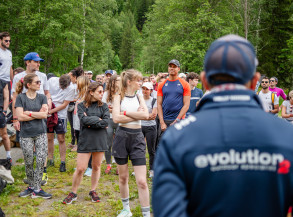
[258, 77, 279, 114]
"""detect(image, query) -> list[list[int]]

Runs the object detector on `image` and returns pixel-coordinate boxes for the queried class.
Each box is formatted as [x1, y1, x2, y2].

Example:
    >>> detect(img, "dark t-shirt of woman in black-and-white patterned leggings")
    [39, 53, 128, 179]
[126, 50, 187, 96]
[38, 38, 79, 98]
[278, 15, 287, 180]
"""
[15, 93, 47, 138]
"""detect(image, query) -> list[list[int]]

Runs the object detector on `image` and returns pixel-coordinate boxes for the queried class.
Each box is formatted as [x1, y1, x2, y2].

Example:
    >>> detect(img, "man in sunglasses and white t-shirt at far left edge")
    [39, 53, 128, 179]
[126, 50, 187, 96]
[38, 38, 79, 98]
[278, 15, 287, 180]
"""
[0, 32, 13, 100]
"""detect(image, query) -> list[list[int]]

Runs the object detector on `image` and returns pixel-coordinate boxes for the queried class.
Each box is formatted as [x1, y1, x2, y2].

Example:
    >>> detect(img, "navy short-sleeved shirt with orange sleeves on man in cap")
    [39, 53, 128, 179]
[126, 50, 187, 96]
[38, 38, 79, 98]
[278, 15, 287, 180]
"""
[157, 78, 191, 120]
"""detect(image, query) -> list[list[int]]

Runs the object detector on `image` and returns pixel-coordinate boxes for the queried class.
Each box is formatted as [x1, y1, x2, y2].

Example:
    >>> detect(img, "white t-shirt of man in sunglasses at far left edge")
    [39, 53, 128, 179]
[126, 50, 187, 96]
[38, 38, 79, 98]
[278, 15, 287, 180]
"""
[0, 48, 12, 81]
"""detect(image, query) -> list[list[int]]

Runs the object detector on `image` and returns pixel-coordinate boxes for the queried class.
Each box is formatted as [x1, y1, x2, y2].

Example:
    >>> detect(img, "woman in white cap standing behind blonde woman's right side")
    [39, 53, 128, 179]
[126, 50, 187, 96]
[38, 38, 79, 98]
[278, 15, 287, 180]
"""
[141, 82, 157, 178]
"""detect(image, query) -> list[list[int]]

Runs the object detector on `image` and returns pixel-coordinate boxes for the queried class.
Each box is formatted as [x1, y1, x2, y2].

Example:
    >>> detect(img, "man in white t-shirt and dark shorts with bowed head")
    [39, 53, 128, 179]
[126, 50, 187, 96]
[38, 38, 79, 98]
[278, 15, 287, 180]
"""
[47, 74, 75, 172]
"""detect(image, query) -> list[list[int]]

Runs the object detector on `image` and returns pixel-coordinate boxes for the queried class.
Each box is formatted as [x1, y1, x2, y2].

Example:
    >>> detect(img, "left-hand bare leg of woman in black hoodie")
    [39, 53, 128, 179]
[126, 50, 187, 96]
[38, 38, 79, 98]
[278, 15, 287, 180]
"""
[72, 153, 91, 194]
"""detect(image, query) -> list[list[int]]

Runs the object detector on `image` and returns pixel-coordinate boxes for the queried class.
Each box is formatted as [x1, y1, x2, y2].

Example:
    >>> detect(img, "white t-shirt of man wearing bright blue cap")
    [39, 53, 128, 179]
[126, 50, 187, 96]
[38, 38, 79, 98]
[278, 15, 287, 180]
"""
[11, 71, 48, 94]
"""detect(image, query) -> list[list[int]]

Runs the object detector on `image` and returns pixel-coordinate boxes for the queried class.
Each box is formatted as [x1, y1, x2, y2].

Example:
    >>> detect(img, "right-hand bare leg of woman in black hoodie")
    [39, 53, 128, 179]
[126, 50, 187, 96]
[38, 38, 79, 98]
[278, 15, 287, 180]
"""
[91, 152, 104, 191]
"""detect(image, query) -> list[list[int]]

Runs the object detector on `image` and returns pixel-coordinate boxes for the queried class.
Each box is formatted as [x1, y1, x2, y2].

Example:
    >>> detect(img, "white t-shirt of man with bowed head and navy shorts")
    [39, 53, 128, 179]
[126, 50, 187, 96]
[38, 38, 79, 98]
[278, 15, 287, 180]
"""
[52, 84, 74, 119]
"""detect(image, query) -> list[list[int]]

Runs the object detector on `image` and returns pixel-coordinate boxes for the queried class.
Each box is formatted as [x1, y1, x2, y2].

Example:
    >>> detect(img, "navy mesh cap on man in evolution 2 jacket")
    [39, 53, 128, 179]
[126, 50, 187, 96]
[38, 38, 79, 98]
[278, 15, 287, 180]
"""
[204, 35, 258, 85]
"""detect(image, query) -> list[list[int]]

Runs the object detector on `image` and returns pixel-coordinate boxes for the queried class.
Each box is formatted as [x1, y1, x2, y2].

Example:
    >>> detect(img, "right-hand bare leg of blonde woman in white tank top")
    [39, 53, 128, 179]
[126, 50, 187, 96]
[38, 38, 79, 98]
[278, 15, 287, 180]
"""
[133, 165, 150, 207]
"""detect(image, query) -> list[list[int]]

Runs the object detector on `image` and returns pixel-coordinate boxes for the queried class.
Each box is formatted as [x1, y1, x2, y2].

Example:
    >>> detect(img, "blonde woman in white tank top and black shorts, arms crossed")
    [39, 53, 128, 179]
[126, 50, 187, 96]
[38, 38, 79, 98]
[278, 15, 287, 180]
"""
[112, 69, 150, 217]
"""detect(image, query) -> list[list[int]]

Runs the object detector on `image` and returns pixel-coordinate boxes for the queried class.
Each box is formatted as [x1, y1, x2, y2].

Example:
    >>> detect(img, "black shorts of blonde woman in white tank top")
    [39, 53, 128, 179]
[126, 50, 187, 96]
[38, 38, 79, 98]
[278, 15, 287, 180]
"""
[112, 127, 146, 166]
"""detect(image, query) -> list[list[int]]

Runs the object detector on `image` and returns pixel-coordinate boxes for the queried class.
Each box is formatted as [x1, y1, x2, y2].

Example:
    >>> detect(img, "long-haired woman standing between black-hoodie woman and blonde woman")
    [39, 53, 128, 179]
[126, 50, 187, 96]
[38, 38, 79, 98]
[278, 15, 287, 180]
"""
[102, 75, 120, 174]
